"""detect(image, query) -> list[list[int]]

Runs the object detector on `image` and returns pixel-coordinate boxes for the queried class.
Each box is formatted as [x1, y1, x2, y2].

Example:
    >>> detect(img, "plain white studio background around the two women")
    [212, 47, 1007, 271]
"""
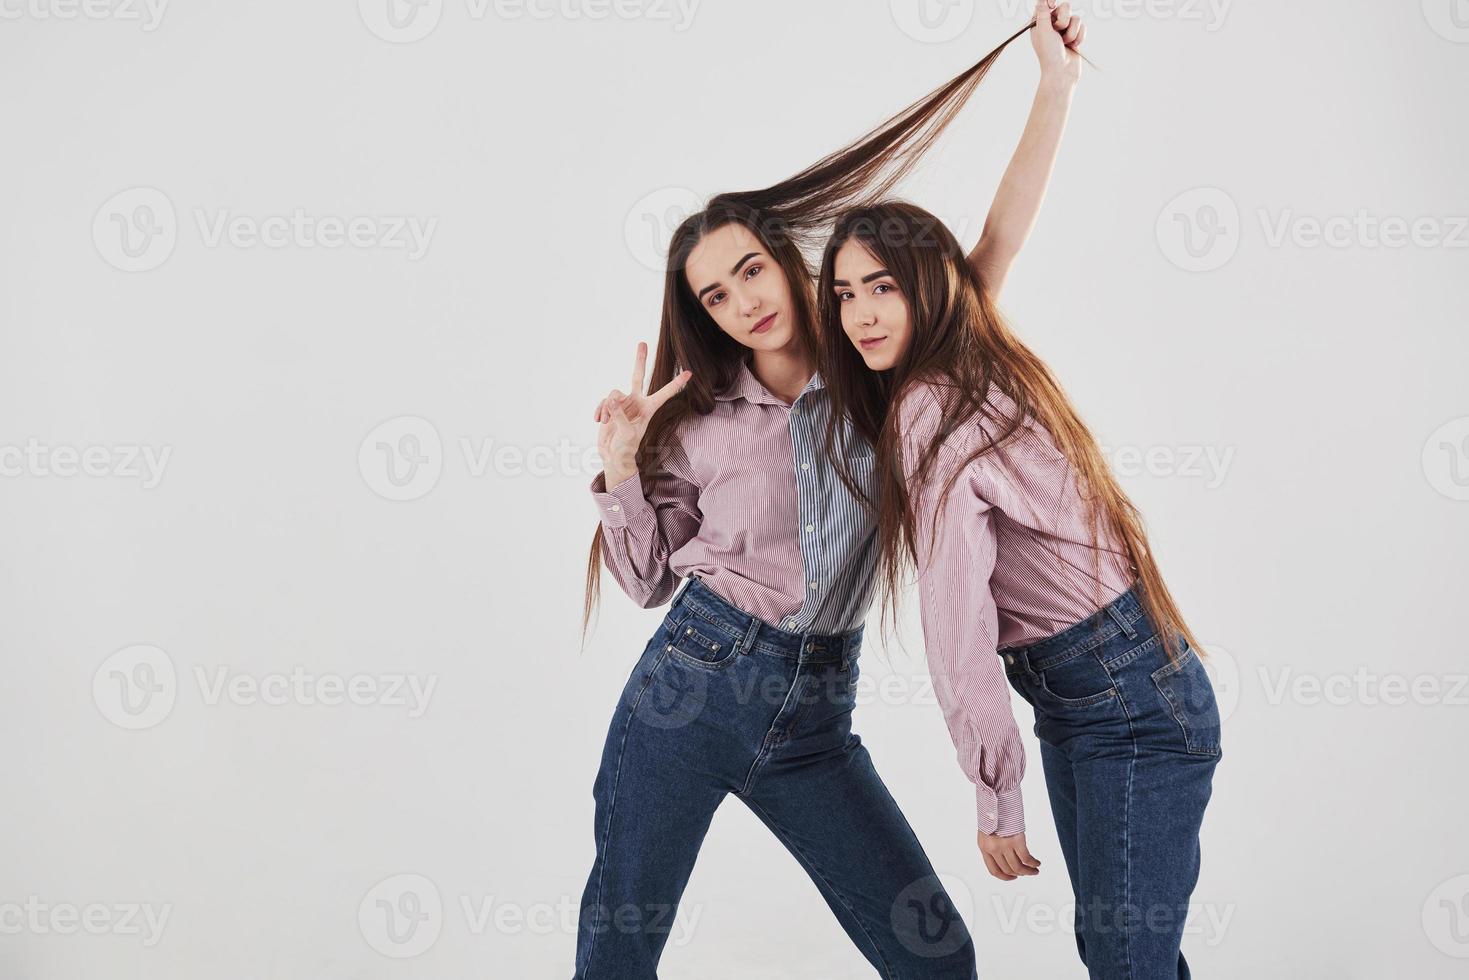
[0, 0, 1469, 980]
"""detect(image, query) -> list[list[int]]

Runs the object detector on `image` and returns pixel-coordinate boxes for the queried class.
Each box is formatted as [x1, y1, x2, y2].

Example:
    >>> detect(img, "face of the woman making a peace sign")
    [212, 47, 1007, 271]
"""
[683, 223, 796, 351]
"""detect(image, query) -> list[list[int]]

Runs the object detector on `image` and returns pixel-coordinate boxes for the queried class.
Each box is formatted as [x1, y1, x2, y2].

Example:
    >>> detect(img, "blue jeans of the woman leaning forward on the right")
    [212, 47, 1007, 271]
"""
[1000, 591, 1219, 980]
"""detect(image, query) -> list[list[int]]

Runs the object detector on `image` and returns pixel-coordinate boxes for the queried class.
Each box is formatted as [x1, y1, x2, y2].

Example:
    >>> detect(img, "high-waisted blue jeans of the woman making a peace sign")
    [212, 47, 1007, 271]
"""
[576, 579, 975, 980]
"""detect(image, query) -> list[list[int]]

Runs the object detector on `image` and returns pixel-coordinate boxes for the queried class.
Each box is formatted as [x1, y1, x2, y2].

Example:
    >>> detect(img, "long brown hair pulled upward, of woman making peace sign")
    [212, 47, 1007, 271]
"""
[582, 21, 1036, 636]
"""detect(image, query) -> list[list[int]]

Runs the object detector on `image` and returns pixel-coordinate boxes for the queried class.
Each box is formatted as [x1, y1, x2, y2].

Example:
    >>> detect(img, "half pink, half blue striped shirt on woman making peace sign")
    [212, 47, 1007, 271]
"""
[592, 363, 877, 633]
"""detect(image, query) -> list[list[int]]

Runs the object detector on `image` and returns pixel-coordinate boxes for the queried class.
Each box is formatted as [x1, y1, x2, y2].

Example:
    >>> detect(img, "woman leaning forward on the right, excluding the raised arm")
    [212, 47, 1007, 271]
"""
[820, 189, 1219, 980]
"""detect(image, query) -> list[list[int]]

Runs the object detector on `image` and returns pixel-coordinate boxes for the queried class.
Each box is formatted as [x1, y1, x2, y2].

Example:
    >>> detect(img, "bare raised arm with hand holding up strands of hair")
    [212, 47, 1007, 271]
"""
[970, 0, 1087, 297]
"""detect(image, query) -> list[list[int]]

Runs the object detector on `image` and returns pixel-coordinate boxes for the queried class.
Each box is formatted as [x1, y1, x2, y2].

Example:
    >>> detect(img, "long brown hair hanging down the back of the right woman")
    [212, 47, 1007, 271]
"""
[818, 201, 1202, 657]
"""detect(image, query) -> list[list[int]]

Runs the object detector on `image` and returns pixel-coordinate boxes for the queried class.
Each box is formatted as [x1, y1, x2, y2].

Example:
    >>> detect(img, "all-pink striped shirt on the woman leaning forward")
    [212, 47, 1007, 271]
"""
[898, 383, 1133, 835]
